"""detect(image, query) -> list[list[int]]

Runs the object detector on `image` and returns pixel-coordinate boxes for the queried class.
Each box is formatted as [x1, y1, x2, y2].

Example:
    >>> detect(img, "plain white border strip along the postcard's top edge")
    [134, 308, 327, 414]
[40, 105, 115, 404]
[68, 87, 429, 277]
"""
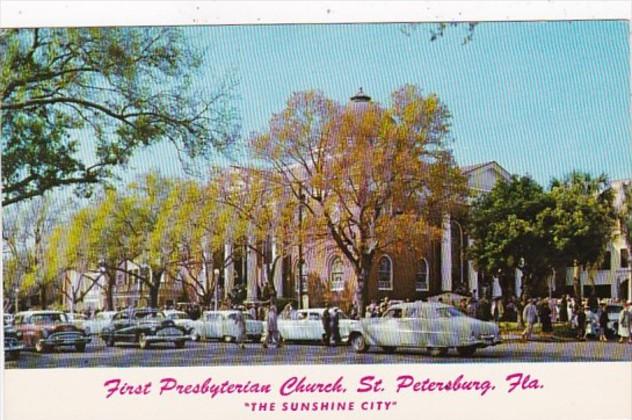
[0, 0, 632, 27]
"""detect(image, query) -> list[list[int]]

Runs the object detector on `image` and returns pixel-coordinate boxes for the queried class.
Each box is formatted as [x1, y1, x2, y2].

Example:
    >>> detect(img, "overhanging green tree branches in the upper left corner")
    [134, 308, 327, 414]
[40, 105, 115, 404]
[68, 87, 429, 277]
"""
[0, 28, 237, 206]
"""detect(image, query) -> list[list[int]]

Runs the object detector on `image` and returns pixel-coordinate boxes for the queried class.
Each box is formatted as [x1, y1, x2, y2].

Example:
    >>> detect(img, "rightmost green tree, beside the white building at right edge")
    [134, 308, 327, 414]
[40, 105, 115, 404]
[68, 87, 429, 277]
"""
[541, 171, 616, 296]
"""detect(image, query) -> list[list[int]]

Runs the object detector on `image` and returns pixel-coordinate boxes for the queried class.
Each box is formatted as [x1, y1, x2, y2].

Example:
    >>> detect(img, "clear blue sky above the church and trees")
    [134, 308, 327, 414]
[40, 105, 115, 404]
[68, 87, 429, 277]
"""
[124, 21, 632, 184]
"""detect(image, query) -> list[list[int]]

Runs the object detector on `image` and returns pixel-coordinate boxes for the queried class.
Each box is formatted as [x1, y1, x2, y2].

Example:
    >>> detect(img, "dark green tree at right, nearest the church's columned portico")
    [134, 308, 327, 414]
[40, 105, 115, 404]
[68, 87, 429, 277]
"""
[468, 175, 553, 295]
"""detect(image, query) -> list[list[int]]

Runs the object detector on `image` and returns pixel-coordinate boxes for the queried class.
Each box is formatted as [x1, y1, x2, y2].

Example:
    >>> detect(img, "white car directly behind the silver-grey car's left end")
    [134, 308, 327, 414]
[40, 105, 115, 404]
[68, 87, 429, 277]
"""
[277, 308, 359, 342]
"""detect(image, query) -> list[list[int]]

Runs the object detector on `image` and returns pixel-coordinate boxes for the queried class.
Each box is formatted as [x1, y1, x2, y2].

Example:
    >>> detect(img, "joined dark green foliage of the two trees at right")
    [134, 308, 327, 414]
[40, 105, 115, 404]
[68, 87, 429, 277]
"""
[469, 172, 615, 296]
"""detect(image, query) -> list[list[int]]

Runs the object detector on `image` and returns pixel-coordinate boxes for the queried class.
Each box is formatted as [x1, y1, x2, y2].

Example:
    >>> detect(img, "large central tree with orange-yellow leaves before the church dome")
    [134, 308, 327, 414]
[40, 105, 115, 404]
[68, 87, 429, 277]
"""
[252, 85, 466, 311]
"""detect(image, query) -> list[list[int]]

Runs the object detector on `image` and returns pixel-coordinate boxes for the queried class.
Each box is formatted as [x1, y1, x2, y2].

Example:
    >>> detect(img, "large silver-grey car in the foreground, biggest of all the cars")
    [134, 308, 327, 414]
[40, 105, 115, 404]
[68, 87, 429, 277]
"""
[349, 302, 501, 356]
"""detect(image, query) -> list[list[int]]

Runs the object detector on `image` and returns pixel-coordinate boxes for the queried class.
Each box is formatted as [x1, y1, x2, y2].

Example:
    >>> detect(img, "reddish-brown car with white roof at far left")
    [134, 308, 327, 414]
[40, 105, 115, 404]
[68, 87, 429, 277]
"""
[14, 311, 90, 353]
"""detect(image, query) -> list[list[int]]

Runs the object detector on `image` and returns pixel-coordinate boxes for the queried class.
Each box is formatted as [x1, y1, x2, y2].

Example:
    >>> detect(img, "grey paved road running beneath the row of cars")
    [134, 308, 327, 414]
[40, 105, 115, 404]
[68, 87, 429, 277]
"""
[5, 338, 632, 369]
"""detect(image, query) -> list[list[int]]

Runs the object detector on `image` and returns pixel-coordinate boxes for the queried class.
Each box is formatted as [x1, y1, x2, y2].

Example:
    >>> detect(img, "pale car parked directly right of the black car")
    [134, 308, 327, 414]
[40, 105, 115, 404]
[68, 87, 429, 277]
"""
[191, 310, 263, 342]
